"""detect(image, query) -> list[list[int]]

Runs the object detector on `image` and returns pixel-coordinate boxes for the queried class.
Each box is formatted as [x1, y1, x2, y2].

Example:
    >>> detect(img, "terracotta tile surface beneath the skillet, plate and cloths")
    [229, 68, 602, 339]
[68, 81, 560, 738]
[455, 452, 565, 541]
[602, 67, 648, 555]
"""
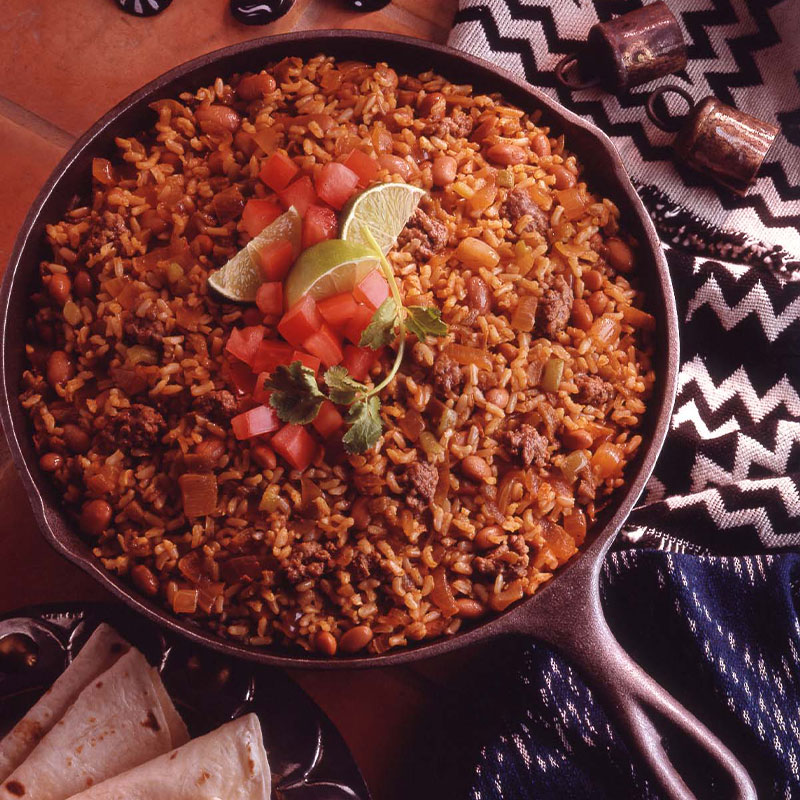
[0, 0, 468, 800]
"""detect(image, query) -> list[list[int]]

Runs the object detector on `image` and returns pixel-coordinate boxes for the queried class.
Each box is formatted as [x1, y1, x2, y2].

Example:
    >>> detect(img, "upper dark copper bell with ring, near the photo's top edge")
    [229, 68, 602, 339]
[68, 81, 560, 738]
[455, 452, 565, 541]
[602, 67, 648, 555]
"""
[555, 0, 687, 93]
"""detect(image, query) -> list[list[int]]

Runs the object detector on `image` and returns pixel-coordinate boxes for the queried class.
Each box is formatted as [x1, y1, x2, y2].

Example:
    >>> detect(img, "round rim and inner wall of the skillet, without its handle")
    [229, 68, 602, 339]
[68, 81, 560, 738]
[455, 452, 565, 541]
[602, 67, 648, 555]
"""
[0, 31, 678, 668]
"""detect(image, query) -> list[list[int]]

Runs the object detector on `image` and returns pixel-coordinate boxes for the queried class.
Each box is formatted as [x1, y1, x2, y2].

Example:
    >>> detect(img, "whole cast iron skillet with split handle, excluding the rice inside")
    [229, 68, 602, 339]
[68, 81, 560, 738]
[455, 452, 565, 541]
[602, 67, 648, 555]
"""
[0, 31, 756, 800]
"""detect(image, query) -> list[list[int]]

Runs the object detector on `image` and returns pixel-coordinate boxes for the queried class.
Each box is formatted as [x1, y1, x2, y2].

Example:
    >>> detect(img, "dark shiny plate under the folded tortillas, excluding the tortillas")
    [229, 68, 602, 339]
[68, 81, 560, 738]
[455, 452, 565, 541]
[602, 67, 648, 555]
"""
[0, 603, 370, 800]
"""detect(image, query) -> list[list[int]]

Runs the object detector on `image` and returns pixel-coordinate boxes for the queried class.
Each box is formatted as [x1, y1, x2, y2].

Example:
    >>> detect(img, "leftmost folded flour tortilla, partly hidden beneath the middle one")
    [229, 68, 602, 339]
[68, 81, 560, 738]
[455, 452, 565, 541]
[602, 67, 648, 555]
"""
[0, 623, 131, 782]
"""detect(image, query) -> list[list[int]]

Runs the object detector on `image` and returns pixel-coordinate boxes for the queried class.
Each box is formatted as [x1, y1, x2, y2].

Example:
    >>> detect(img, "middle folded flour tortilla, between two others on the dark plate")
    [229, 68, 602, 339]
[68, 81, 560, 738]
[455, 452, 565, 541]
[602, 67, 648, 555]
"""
[0, 649, 189, 800]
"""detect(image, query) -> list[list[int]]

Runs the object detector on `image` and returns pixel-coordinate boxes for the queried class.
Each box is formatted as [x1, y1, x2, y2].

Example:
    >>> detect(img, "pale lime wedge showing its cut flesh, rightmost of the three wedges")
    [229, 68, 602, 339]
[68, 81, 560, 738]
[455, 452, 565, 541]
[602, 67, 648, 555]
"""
[339, 183, 425, 255]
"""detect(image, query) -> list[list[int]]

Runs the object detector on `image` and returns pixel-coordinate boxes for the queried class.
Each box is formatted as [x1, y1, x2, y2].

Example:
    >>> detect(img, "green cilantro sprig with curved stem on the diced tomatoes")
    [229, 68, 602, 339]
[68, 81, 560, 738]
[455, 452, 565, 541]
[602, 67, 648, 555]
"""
[265, 225, 447, 453]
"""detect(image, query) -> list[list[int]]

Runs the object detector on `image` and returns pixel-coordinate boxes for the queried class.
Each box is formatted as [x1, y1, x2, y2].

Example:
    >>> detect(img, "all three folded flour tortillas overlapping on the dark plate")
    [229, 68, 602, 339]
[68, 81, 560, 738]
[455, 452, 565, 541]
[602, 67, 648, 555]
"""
[0, 625, 270, 800]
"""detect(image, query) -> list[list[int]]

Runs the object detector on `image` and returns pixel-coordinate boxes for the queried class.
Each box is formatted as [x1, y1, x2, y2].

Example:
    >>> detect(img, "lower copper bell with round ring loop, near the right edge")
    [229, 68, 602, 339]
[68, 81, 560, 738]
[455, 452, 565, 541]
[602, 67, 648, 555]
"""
[646, 84, 780, 195]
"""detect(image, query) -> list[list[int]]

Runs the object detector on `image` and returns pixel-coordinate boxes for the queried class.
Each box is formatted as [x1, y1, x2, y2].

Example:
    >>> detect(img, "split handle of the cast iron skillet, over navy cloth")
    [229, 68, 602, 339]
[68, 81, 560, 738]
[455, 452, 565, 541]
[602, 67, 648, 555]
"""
[504, 552, 757, 800]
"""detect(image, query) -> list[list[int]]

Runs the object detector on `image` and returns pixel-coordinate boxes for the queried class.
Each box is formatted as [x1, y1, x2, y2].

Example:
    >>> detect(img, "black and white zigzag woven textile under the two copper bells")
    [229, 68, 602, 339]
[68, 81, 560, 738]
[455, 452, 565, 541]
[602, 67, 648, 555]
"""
[450, 0, 800, 554]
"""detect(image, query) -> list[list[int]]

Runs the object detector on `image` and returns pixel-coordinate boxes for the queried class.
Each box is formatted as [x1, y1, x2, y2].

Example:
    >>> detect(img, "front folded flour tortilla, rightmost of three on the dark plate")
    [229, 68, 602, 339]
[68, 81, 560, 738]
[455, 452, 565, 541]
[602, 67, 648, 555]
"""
[61, 714, 271, 800]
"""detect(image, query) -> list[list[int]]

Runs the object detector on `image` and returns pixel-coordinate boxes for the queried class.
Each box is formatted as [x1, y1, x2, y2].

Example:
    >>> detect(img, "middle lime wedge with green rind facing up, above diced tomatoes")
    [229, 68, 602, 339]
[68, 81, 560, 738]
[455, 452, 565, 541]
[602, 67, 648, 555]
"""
[284, 239, 380, 307]
